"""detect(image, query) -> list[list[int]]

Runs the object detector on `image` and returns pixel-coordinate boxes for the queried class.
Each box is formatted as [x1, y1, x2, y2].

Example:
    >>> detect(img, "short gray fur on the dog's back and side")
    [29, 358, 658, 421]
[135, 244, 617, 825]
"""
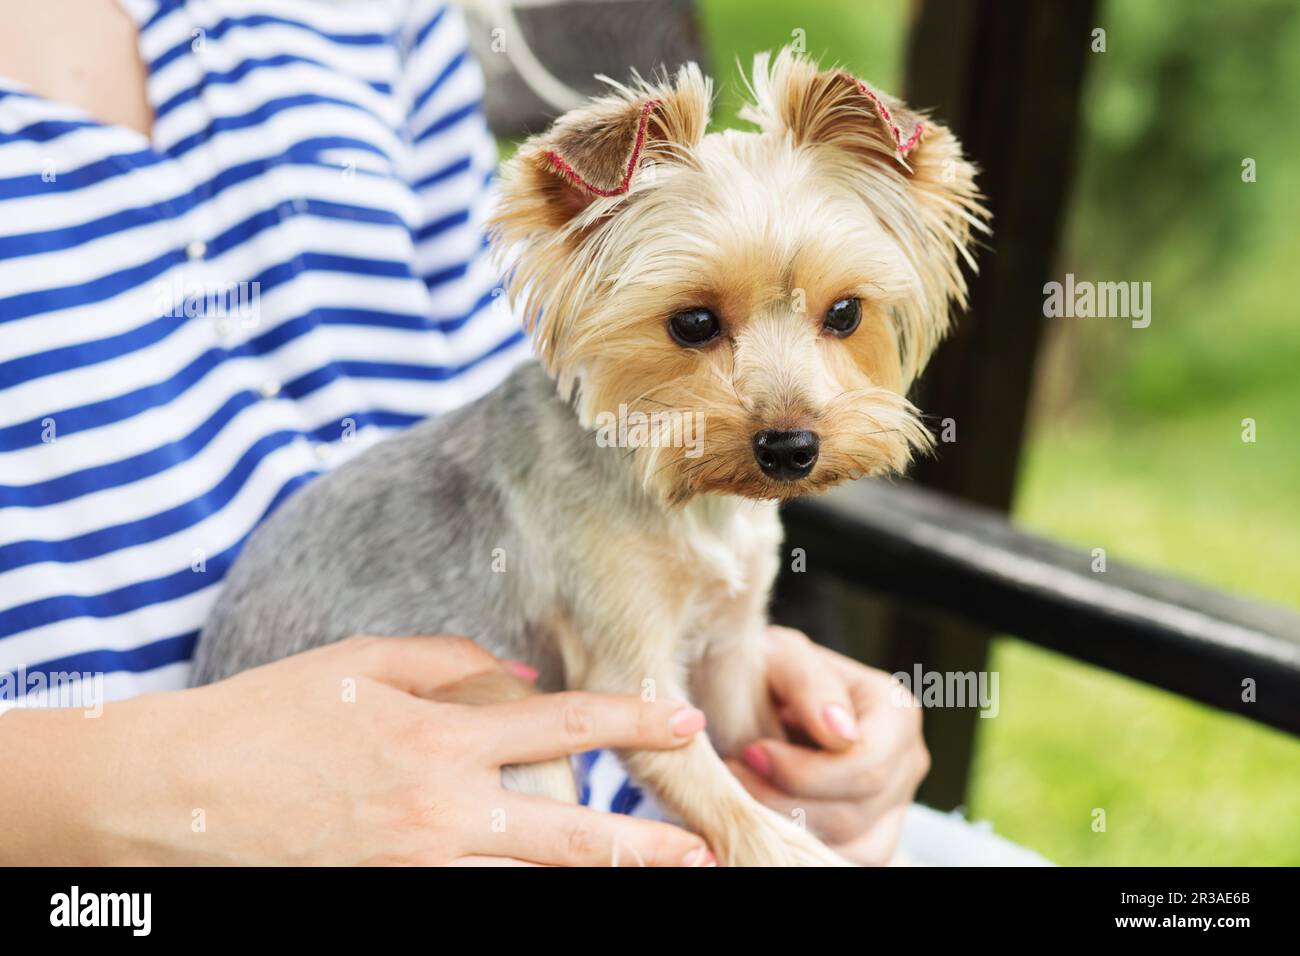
[192, 363, 624, 687]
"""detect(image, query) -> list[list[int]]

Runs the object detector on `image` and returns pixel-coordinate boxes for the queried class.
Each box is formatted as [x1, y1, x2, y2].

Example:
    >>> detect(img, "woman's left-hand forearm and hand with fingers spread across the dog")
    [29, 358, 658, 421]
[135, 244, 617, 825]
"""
[0, 637, 712, 866]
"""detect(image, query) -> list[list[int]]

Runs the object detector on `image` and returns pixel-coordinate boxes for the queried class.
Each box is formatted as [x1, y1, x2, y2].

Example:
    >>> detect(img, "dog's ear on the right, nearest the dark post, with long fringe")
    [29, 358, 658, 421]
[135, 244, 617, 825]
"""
[740, 48, 988, 381]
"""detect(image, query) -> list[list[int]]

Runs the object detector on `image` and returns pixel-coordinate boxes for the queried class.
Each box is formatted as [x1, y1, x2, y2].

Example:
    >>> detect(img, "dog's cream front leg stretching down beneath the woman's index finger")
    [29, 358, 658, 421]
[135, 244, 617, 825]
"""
[582, 658, 845, 866]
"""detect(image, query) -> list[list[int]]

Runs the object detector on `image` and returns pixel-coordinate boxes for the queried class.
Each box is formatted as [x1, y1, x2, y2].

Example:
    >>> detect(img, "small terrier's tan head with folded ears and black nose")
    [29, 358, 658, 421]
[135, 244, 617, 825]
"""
[493, 51, 983, 503]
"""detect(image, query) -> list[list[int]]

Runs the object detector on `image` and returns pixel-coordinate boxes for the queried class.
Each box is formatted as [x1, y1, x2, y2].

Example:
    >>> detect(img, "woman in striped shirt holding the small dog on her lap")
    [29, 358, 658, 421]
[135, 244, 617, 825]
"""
[0, 0, 987, 866]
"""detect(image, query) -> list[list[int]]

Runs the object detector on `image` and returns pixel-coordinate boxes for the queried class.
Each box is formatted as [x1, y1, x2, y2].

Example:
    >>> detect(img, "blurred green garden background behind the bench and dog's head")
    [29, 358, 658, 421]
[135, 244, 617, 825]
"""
[701, 0, 1300, 865]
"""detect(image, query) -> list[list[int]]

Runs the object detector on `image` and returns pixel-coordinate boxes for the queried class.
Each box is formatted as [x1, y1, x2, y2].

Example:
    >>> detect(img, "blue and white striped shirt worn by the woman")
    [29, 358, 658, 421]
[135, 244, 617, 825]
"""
[0, 0, 528, 702]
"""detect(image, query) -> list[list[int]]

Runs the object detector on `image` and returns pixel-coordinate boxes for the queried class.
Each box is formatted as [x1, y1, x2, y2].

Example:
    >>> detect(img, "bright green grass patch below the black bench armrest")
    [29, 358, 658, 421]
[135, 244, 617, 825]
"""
[971, 640, 1300, 866]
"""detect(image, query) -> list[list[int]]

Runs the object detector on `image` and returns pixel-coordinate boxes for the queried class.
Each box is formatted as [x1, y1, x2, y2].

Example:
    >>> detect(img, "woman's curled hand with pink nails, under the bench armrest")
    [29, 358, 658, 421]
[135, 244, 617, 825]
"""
[728, 627, 930, 865]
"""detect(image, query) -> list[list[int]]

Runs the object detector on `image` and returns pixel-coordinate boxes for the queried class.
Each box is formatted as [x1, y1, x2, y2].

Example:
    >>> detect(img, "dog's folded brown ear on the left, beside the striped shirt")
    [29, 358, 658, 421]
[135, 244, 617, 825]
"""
[494, 64, 712, 231]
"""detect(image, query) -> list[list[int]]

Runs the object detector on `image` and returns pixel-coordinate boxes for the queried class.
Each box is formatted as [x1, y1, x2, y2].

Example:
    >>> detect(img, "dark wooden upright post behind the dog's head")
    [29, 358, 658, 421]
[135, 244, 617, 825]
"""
[884, 0, 1099, 808]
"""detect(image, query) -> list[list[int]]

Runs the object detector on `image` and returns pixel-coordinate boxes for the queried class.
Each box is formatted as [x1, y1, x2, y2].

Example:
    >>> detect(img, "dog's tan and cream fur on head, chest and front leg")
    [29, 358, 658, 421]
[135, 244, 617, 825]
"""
[478, 51, 984, 864]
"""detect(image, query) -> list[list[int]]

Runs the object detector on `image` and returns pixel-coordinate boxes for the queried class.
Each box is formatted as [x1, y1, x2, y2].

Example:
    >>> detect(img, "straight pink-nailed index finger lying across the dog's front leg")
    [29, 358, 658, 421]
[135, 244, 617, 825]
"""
[472, 691, 705, 763]
